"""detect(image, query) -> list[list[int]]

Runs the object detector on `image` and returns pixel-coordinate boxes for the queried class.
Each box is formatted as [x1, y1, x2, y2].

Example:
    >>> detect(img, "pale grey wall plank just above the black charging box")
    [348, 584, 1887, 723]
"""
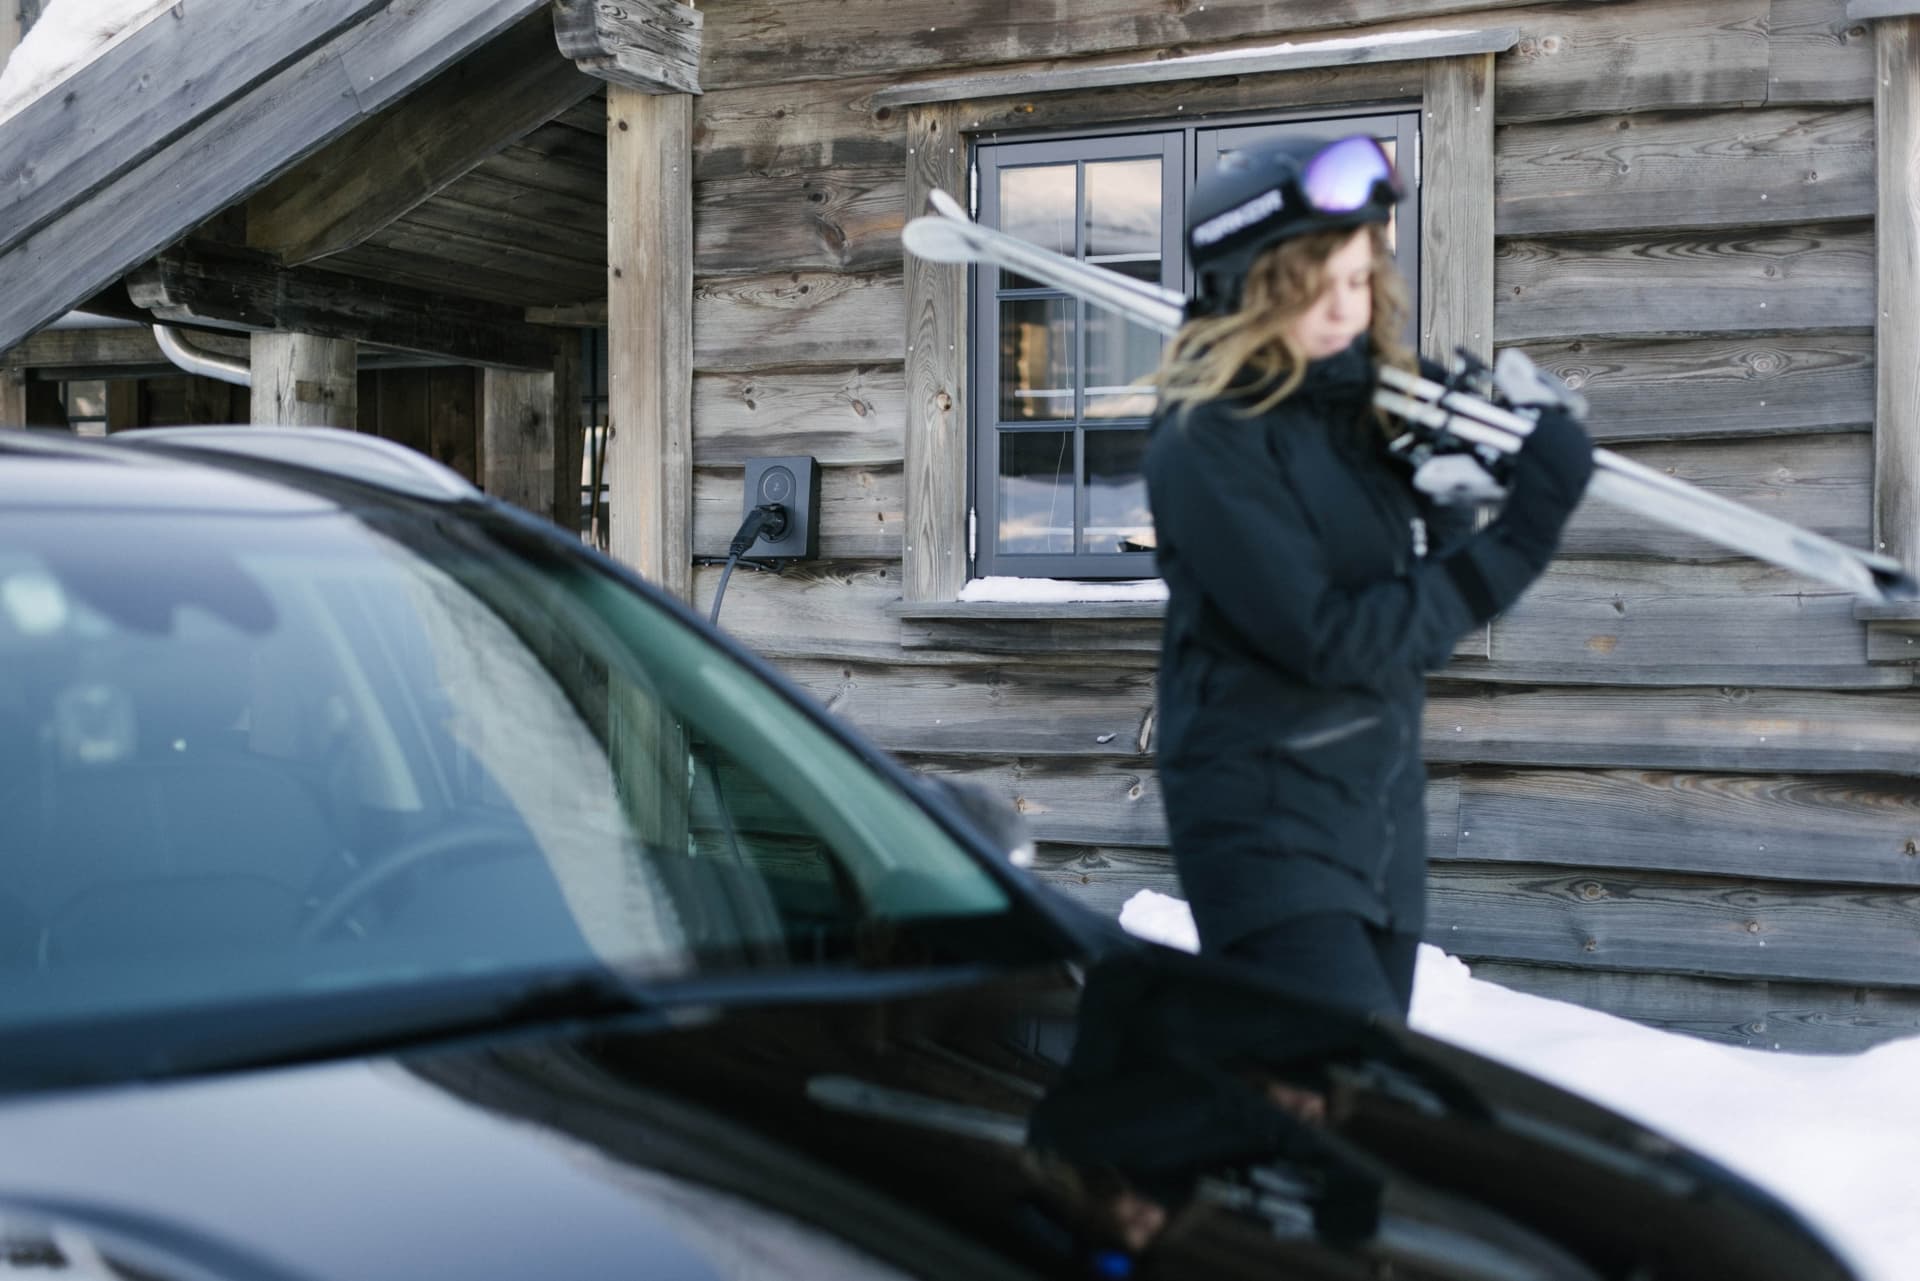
[693, 365, 906, 467]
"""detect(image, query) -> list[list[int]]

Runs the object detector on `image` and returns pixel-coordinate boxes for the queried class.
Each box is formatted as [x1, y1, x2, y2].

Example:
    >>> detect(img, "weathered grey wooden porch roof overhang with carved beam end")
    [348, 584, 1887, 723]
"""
[0, 0, 699, 369]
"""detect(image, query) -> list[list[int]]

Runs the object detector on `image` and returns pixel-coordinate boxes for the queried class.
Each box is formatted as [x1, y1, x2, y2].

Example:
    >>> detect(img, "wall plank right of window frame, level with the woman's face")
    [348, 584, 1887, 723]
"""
[1494, 223, 1874, 344]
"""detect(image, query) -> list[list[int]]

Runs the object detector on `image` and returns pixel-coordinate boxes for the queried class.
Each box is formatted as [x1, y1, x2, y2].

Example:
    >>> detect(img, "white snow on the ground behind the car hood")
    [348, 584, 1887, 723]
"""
[1119, 889, 1920, 1281]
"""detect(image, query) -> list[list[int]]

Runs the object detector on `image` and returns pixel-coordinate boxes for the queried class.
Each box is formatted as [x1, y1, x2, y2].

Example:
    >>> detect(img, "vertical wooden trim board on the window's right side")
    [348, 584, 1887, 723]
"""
[1419, 54, 1494, 361]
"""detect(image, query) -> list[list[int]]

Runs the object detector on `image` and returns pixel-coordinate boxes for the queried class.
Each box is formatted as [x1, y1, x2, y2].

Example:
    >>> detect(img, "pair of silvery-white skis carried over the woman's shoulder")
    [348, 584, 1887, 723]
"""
[900, 190, 1920, 603]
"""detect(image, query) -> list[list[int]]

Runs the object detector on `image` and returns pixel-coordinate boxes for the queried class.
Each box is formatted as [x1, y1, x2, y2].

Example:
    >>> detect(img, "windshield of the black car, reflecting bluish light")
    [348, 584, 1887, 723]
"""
[0, 485, 1048, 1067]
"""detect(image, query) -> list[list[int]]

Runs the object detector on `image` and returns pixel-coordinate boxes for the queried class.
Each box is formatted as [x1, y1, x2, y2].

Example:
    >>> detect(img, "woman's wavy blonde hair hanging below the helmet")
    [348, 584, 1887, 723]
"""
[1152, 223, 1417, 426]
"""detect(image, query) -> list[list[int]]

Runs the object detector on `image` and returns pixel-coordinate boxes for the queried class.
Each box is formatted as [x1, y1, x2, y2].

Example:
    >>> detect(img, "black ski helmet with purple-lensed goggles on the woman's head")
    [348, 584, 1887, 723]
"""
[1187, 134, 1402, 317]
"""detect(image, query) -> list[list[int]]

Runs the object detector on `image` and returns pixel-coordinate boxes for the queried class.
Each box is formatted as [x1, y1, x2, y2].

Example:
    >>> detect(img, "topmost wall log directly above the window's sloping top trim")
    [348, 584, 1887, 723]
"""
[701, 0, 1551, 90]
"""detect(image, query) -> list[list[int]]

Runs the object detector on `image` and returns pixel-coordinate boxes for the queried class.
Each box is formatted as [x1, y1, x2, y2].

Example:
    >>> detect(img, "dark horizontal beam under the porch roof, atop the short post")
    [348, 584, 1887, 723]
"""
[127, 242, 553, 371]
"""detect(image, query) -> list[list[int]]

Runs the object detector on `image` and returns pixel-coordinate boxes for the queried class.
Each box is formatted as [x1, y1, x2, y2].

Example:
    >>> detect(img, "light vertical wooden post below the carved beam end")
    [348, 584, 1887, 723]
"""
[607, 85, 693, 599]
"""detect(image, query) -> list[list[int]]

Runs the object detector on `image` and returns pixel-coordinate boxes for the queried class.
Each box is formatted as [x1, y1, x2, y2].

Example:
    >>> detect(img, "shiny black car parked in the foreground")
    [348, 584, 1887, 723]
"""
[0, 428, 1851, 1281]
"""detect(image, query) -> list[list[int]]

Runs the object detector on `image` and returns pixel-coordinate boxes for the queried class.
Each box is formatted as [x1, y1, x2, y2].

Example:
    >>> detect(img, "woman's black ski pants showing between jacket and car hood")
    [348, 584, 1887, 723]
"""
[1227, 912, 1421, 1020]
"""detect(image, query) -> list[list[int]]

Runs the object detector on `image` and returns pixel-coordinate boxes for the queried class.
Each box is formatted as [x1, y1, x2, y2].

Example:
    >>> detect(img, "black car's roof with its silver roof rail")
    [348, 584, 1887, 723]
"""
[0, 426, 480, 515]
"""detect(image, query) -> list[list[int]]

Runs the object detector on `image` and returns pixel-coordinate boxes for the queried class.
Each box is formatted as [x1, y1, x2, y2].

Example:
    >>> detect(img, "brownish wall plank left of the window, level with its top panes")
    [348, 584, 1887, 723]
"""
[693, 164, 906, 275]
